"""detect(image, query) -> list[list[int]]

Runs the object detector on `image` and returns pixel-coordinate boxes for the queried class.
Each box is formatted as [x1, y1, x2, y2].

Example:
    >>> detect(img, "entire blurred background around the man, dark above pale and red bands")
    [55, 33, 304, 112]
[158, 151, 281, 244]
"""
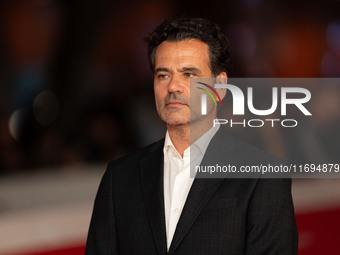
[0, 0, 340, 255]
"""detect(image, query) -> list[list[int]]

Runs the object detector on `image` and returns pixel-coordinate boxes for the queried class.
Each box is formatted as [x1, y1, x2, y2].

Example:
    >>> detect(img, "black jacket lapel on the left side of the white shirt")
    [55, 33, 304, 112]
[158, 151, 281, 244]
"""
[140, 140, 166, 254]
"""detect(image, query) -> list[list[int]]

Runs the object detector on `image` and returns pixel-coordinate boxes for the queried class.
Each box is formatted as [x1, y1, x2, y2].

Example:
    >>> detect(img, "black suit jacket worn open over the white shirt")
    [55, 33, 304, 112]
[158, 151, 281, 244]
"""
[85, 128, 297, 255]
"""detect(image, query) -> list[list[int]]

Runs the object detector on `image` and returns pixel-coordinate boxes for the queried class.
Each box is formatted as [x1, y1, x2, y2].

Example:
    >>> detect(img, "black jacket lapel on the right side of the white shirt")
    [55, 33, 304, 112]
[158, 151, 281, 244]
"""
[169, 128, 236, 254]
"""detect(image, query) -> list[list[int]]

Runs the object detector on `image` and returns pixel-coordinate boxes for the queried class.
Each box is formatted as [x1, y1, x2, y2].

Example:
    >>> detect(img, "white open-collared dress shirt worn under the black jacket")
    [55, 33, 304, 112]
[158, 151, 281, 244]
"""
[163, 126, 219, 249]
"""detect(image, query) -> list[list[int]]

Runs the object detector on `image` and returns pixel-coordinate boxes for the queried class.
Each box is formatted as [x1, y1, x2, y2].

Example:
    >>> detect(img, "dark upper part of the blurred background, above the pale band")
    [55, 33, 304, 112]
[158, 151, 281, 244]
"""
[0, 0, 340, 174]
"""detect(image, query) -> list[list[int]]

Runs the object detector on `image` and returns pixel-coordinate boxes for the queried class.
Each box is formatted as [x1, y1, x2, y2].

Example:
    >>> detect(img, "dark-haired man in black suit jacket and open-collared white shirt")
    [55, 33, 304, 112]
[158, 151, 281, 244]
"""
[86, 18, 297, 255]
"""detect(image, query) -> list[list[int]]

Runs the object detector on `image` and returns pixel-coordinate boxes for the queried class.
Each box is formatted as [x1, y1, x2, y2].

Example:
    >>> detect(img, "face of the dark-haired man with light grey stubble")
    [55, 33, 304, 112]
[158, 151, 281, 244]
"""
[154, 39, 212, 125]
